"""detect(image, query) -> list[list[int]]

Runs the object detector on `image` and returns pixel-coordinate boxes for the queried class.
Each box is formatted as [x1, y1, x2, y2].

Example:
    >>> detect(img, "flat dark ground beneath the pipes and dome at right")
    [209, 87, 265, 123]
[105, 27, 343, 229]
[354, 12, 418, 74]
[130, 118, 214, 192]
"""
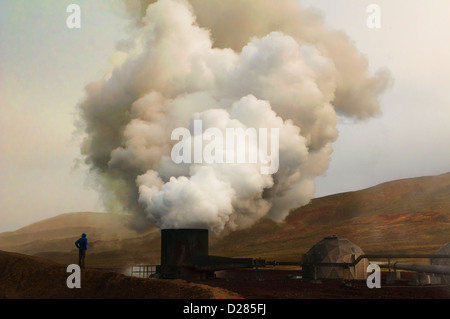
[198, 269, 450, 300]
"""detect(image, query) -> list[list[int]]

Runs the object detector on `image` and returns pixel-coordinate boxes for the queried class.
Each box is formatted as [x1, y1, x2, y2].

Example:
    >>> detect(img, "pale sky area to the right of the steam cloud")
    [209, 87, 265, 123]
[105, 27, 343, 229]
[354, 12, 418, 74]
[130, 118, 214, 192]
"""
[301, 0, 450, 196]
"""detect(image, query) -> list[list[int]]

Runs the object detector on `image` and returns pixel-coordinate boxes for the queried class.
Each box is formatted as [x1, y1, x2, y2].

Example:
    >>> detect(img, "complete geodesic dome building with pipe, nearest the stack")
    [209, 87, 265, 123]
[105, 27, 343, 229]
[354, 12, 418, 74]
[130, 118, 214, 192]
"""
[302, 236, 369, 279]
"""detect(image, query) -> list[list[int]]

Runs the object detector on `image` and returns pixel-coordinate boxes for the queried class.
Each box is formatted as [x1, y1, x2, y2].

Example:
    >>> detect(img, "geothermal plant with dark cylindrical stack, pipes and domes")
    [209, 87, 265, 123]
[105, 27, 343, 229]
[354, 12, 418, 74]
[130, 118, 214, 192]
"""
[133, 229, 450, 285]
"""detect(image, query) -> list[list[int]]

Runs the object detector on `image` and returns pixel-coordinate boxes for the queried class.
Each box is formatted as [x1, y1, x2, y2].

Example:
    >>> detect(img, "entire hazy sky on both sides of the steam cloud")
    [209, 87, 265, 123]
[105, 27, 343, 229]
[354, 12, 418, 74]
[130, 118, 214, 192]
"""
[0, 0, 450, 232]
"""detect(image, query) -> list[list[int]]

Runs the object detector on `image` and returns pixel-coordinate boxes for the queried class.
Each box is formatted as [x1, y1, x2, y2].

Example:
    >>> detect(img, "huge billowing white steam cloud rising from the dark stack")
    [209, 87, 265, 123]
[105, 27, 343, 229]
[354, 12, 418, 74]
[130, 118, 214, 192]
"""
[78, 0, 389, 233]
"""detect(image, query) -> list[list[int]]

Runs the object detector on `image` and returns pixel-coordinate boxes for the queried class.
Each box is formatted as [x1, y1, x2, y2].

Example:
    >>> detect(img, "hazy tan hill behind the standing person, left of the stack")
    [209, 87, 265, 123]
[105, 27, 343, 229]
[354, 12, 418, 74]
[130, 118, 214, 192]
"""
[0, 212, 160, 268]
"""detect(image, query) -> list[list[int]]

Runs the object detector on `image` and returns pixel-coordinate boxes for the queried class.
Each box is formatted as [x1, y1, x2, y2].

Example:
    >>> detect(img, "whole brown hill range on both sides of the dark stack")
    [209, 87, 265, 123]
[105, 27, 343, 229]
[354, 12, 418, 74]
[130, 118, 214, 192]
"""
[0, 173, 450, 267]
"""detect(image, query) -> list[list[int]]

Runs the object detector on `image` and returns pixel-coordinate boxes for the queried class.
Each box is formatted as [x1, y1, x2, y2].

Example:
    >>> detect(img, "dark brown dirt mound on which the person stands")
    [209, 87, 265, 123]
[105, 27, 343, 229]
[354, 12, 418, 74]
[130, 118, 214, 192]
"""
[0, 251, 240, 299]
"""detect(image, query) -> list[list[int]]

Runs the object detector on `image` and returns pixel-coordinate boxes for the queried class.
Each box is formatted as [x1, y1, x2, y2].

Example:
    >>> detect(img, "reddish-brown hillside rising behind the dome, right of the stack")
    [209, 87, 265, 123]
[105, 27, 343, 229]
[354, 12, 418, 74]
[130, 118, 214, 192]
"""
[213, 173, 450, 261]
